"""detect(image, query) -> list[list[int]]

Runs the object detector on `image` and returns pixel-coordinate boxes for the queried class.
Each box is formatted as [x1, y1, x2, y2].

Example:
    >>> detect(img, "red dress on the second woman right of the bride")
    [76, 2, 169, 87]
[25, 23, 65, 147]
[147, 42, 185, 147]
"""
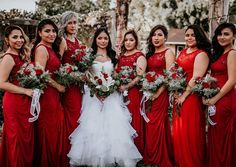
[144, 49, 173, 167]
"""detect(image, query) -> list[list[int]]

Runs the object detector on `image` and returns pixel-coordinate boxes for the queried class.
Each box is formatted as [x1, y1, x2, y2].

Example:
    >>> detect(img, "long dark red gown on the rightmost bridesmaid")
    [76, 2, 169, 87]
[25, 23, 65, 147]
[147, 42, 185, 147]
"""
[208, 49, 236, 167]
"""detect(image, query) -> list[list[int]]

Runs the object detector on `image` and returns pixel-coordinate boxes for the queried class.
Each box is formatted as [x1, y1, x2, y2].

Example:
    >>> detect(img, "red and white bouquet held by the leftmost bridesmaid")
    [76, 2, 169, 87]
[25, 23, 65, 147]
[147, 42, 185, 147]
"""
[16, 63, 50, 91]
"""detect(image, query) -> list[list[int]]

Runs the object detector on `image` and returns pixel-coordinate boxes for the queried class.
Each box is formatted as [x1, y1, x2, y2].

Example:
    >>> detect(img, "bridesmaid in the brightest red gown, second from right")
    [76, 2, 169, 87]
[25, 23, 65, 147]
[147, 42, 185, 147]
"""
[172, 25, 211, 167]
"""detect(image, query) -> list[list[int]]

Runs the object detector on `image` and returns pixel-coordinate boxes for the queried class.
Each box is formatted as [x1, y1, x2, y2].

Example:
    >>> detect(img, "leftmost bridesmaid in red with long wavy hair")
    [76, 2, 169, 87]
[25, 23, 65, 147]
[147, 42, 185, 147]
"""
[0, 25, 34, 167]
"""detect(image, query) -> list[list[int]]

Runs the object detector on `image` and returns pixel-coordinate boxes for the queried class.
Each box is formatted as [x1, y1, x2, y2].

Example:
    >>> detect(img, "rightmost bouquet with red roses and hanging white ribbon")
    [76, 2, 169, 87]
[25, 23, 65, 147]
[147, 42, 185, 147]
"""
[192, 73, 220, 125]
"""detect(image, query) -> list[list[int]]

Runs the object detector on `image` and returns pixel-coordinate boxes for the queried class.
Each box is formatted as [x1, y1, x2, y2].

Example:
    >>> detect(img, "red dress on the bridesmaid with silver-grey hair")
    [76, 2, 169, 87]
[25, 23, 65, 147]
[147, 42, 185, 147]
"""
[62, 39, 82, 166]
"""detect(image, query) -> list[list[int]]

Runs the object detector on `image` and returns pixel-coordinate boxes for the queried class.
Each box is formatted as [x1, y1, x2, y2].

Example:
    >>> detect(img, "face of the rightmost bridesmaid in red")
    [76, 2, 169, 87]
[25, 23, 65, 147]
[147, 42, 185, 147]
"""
[217, 28, 236, 47]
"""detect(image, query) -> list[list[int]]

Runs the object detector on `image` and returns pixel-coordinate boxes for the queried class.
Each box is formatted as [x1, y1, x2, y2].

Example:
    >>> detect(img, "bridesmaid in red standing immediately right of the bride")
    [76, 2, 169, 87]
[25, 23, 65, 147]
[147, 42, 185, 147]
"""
[117, 30, 147, 154]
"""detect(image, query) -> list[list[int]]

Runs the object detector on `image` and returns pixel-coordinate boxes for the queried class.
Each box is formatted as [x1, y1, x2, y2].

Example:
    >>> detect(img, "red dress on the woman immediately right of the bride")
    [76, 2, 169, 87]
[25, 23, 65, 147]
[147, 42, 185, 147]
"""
[118, 52, 144, 154]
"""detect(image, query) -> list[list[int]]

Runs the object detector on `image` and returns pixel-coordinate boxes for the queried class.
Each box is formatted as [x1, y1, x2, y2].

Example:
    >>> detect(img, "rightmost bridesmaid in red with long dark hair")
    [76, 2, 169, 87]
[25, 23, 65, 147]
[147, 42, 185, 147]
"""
[203, 23, 236, 167]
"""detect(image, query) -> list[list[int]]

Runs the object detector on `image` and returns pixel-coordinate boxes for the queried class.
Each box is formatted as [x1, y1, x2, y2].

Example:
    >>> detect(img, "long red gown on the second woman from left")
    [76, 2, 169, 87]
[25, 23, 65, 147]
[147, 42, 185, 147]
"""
[34, 45, 64, 167]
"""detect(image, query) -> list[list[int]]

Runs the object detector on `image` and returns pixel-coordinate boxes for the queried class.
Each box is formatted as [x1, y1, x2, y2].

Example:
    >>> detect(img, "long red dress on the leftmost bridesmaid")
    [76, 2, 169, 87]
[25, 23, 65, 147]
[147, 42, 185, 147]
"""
[0, 54, 34, 167]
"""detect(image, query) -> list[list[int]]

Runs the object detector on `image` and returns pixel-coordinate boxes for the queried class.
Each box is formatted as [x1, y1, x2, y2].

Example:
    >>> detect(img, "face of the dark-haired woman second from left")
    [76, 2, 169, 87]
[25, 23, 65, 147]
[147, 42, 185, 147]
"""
[39, 24, 57, 44]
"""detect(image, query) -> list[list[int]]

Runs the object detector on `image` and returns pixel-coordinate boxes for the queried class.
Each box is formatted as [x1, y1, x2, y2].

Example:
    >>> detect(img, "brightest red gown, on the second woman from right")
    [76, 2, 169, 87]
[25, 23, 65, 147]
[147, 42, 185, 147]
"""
[172, 49, 207, 167]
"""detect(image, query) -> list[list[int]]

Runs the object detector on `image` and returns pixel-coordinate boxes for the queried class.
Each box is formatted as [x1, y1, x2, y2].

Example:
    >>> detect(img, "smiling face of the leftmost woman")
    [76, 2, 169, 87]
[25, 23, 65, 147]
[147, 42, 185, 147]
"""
[5, 29, 25, 50]
